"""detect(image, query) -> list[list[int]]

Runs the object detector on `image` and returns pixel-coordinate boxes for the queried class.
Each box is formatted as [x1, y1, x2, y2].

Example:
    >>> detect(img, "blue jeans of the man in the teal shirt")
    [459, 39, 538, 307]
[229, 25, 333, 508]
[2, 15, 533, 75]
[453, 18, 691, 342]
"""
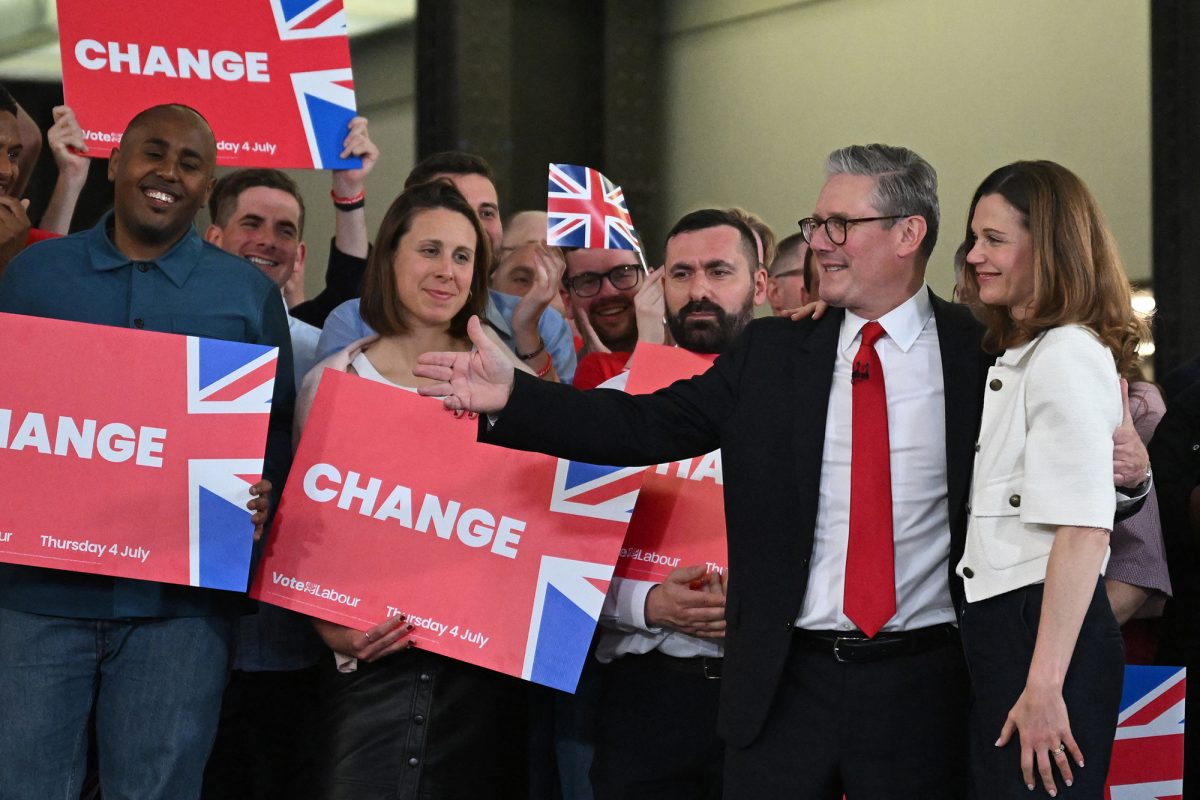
[0, 609, 233, 800]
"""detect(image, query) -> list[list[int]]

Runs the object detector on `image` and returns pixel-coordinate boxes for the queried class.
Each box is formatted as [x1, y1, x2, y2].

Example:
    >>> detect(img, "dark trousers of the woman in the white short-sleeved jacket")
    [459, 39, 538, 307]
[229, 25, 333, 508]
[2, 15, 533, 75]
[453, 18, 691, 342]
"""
[962, 581, 1124, 800]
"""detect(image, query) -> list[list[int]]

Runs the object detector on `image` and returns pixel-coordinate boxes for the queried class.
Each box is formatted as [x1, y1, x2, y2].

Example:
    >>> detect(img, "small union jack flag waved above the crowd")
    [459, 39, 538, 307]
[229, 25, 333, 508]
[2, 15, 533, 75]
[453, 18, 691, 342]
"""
[546, 164, 642, 252]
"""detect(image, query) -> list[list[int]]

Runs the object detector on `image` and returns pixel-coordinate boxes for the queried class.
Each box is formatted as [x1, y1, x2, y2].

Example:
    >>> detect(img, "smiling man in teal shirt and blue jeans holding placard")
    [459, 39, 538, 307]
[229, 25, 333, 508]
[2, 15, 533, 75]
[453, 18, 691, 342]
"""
[0, 104, 295, 800]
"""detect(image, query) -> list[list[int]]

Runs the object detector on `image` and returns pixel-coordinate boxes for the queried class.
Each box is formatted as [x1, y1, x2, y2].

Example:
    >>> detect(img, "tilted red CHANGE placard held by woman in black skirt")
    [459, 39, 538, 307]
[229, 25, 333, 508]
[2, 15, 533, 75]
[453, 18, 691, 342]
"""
[251, 371, 628, 691]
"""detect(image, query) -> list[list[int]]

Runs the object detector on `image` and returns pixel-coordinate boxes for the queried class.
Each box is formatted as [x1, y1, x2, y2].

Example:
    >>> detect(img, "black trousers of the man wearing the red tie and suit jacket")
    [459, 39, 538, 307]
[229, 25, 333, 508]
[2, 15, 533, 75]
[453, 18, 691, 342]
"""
[725, 638, 967, 800]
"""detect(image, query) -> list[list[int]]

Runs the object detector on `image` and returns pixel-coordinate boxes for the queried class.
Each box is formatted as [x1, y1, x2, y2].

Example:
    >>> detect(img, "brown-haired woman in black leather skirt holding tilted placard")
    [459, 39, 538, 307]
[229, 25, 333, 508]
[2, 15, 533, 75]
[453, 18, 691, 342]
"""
[296, 180, 526, 800]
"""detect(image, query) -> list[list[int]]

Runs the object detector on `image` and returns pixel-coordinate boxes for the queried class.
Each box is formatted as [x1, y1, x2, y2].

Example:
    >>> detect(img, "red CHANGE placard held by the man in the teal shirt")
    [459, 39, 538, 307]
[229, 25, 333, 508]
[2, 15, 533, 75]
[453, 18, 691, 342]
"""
[0, 314, 278, 591]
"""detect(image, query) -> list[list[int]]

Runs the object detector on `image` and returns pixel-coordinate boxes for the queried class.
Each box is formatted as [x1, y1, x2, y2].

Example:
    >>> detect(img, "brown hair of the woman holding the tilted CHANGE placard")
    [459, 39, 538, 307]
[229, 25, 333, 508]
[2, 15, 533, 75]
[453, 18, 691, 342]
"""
[359, 179, 492, 338]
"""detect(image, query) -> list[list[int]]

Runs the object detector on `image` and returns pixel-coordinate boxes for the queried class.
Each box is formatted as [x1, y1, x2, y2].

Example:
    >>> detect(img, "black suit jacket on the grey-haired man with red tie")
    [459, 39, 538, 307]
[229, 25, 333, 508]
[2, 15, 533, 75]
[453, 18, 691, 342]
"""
[480, 295, 986, 747]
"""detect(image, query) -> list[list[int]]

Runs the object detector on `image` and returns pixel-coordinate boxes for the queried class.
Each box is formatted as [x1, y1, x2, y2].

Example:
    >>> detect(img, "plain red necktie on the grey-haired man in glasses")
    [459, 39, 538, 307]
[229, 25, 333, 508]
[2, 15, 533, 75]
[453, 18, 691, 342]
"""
[842, 323, 896, 636]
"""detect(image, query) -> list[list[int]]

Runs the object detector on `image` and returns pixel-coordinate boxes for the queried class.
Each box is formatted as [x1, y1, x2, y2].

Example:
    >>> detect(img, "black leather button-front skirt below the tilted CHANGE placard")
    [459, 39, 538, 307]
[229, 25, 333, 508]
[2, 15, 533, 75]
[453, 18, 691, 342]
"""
[316, 650, 528, 800]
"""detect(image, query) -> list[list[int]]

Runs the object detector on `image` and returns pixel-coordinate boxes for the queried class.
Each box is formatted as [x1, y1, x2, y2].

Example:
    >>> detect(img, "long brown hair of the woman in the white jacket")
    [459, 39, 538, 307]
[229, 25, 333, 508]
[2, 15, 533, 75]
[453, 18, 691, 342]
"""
[962, 161, 1150, 374]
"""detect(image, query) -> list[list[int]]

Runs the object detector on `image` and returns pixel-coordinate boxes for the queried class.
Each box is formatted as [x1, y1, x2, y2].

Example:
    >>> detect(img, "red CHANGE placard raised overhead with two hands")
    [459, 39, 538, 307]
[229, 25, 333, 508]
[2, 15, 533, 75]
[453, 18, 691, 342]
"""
[58, 0, 361, 169]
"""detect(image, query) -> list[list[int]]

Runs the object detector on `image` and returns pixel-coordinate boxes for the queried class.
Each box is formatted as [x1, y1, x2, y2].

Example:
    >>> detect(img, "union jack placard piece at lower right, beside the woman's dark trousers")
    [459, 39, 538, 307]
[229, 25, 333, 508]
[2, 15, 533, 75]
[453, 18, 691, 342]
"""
[1104, 667, 1187, 800]
